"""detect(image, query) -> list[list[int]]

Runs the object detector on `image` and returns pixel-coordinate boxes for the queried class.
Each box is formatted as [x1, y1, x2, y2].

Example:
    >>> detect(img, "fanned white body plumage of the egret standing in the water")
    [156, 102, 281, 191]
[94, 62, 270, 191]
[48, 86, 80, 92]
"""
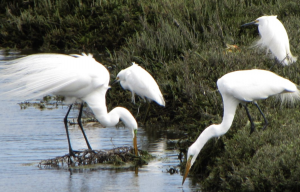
[0, 54, 109, 99]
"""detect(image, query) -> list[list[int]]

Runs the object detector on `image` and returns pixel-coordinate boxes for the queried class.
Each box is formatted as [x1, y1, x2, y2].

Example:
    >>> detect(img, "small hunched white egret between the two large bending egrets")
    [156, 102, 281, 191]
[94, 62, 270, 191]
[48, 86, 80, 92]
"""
[115, 62, 166, 123]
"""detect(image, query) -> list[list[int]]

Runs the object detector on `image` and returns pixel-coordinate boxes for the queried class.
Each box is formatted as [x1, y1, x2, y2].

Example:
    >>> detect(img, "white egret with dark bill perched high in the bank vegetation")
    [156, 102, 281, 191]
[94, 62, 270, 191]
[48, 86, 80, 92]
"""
[242, 15, 297, 65]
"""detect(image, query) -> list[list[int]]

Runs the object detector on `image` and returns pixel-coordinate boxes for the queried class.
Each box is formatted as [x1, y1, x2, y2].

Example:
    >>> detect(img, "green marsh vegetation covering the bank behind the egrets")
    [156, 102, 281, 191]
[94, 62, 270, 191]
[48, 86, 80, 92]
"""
[0, 0, 300, 191]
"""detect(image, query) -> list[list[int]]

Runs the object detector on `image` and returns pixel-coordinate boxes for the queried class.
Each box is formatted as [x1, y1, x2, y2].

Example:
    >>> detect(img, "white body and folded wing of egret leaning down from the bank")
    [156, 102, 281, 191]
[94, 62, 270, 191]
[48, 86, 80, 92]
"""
[218, 69, 298, 102]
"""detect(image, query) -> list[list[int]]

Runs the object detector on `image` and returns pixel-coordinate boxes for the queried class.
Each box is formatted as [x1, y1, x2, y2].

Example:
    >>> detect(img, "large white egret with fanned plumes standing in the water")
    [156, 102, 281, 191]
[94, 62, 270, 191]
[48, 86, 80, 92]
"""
[0, 54, 137, 155]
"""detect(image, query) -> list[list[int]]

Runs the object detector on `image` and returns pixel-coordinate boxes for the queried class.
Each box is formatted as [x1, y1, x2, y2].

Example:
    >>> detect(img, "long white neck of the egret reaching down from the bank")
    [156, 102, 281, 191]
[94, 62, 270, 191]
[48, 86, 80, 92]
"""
[188, 95, 239, 163]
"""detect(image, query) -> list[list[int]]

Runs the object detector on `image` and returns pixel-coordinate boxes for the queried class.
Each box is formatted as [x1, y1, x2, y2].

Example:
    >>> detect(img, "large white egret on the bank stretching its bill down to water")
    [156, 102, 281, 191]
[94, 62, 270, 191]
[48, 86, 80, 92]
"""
[182, 69, 300, 184]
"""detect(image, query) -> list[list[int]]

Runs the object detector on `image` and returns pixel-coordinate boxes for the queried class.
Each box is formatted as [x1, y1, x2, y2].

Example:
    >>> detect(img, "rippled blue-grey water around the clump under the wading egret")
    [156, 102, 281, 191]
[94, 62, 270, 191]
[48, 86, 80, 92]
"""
[0, 51, 199, 192]
